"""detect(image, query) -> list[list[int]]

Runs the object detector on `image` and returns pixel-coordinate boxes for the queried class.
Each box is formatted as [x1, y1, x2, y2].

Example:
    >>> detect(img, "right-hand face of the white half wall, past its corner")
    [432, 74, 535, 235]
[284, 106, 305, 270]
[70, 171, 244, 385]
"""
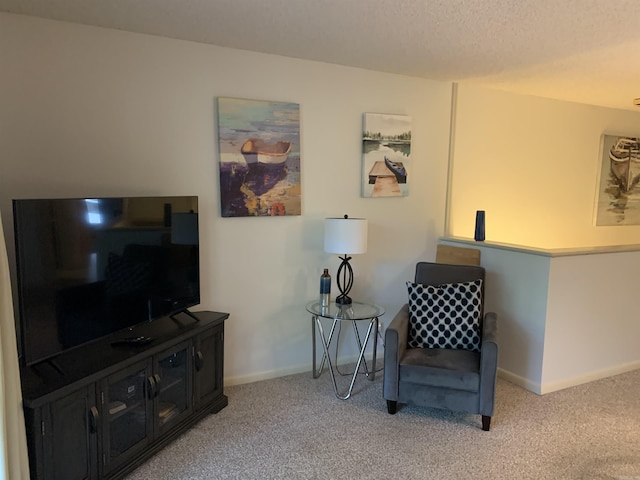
[542, 251, 640, 393]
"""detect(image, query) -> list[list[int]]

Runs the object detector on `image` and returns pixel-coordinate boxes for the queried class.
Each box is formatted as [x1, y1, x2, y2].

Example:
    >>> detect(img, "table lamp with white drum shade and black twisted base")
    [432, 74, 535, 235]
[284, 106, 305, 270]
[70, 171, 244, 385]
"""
[324, 215, 367, 305]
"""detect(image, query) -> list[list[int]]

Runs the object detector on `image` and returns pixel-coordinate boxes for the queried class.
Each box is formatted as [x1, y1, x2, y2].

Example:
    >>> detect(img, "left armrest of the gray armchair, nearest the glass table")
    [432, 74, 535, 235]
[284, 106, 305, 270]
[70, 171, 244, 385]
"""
[383, 304, 409, 400]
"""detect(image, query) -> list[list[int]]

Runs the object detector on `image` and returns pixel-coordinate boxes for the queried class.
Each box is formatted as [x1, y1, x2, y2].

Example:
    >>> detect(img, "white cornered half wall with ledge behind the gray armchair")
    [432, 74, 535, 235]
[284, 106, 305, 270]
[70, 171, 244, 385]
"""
[442, 238, 640, 394]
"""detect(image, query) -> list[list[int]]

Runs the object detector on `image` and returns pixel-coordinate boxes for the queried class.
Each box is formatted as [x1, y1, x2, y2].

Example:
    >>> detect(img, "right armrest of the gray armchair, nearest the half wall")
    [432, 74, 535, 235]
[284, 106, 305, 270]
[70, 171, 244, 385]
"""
[479, 312, 498, 416]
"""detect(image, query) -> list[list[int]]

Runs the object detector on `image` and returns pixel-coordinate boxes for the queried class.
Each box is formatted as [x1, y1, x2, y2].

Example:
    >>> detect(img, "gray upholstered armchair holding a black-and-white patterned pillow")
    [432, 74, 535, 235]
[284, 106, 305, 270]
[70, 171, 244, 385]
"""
[383, 262, 498, 430]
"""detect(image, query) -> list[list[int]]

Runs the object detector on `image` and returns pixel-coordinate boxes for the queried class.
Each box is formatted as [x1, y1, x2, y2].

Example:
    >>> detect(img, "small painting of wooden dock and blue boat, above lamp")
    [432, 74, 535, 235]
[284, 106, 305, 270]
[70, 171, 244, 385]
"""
[362, 113, 411, 197]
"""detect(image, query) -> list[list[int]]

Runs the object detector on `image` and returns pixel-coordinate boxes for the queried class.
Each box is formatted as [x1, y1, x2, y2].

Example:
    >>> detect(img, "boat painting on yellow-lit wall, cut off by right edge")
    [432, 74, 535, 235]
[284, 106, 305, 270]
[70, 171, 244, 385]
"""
[595, 135, 640, 226]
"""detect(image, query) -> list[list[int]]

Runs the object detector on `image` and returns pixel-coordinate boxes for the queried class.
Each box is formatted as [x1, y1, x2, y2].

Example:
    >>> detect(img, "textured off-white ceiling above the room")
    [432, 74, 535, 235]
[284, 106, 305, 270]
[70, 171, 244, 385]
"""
[0, 0, 640, 110]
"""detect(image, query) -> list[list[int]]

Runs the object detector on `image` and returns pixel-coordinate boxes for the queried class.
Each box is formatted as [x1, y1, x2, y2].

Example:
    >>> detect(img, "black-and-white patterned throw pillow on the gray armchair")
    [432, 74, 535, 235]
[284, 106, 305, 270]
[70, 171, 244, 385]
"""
[407, 280, 482, 352]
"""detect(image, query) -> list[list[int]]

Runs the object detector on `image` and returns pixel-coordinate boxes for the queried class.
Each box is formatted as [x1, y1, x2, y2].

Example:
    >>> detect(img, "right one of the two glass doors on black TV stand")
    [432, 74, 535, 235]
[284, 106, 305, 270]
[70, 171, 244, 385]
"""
[154, 342, 192, 431]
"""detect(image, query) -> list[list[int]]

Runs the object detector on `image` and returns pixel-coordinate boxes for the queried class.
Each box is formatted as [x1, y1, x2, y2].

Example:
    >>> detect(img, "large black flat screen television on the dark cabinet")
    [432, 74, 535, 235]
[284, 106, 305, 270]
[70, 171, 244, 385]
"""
[13, 196, 200, 365]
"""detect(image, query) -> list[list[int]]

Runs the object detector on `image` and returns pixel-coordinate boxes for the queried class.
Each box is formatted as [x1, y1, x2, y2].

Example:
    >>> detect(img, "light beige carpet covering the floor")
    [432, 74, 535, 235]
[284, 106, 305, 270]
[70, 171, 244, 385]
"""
[128, 370, 640, 480]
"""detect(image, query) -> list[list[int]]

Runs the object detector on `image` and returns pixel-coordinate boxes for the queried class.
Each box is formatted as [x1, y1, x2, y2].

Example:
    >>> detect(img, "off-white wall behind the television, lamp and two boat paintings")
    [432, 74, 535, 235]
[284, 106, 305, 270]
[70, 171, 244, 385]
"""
[0, 14, 452, 384]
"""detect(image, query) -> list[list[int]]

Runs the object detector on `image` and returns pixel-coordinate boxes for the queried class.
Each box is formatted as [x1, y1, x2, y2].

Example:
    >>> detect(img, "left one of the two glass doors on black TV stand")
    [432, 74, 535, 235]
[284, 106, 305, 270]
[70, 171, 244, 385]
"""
[102, 362, 152, 471]
